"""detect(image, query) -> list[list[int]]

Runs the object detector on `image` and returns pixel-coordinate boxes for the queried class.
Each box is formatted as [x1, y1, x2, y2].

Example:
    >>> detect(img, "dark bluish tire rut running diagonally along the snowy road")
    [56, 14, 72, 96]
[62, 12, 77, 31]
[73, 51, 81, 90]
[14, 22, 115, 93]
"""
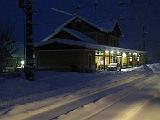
[25, 75, 151, 120]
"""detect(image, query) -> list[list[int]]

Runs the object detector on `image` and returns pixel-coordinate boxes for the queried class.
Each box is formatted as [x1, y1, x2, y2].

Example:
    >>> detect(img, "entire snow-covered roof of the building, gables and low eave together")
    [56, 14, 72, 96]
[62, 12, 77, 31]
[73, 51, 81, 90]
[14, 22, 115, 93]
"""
[35, 16, 144, 53]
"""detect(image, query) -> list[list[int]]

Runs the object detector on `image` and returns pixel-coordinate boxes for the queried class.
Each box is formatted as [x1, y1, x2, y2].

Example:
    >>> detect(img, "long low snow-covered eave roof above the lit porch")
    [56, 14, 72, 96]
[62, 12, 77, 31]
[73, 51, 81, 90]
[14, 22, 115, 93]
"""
[35, 38, 145, 53]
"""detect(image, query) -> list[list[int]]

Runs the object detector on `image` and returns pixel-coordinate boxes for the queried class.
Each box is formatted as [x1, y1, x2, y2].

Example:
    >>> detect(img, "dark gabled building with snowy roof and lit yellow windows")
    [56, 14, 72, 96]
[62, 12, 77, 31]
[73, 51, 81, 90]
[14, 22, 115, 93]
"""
[35, 16, 145, 72]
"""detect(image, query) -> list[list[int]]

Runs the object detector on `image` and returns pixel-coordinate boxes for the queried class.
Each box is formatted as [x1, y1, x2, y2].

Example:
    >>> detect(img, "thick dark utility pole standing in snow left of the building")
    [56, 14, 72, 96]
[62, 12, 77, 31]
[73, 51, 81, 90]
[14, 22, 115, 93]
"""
[19, 0, 35, 80]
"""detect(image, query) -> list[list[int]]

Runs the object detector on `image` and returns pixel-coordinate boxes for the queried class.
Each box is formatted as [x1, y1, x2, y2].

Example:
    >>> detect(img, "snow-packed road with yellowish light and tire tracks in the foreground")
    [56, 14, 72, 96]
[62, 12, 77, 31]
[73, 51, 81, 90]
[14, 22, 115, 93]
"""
[0, 74, 160, 120]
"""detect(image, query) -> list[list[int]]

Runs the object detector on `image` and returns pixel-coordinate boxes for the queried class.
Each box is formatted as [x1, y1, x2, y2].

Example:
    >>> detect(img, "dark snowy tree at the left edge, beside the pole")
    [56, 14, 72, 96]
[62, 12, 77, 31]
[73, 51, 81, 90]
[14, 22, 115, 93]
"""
[0, 21, 16, 72]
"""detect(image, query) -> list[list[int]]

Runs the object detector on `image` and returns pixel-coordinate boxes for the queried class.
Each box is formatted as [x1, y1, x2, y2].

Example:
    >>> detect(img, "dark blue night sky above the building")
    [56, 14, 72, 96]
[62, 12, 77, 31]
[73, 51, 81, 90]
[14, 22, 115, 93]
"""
[0, 0, 160, 62]
